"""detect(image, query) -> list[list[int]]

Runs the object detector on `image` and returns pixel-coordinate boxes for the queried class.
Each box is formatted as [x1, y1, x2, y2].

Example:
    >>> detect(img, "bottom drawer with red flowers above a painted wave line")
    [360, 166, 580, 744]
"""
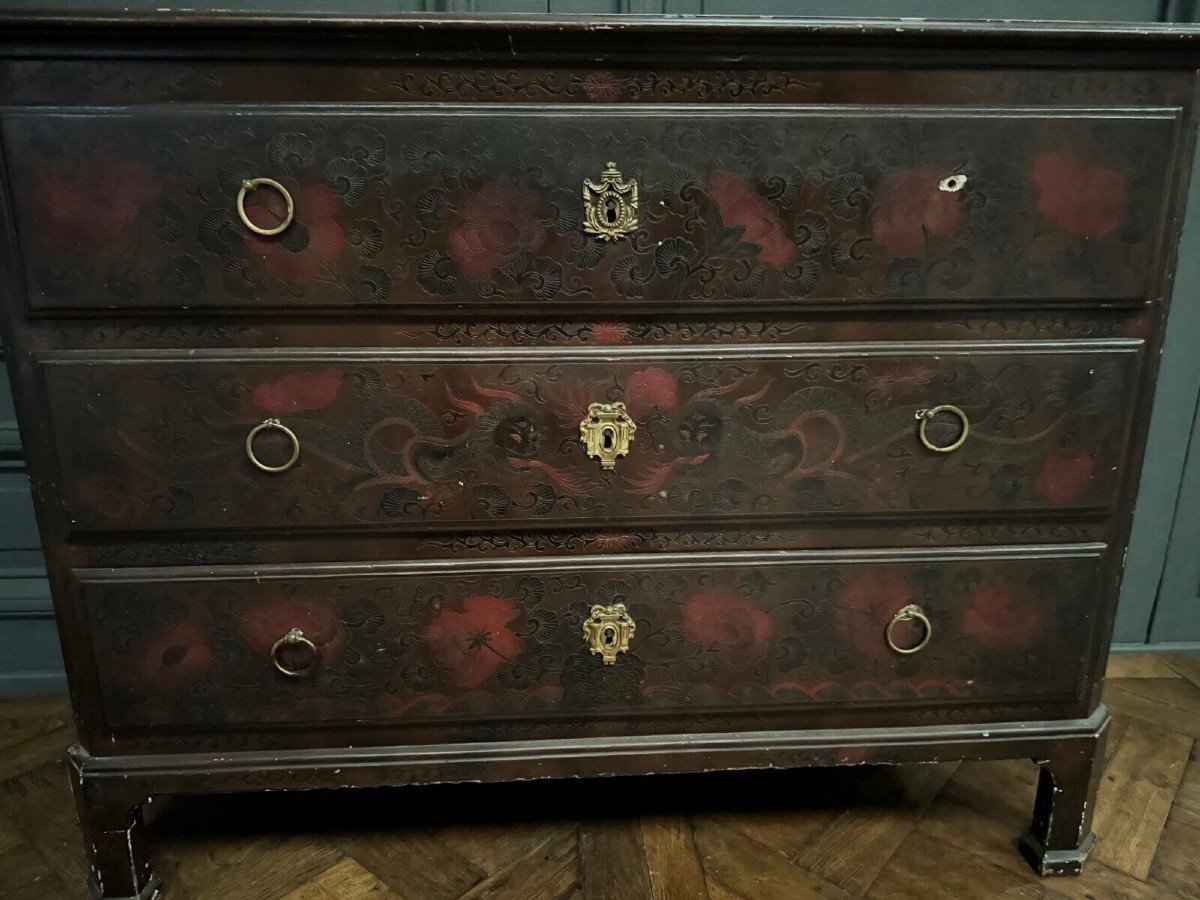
[74, 544, 1105, 731]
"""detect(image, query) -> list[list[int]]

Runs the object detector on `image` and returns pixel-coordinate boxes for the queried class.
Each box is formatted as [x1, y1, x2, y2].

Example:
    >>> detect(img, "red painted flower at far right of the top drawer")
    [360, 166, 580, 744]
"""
[1030, 149, 1127, 238]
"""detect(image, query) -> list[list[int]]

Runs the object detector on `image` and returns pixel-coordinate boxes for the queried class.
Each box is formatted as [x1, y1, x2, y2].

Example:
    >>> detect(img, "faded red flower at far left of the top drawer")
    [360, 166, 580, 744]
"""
[34, 160, 158, 253]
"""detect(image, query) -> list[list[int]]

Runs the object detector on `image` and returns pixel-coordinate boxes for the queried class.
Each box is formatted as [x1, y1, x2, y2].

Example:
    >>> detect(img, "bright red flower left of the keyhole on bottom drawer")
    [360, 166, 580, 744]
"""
[422, 594, 524, 688]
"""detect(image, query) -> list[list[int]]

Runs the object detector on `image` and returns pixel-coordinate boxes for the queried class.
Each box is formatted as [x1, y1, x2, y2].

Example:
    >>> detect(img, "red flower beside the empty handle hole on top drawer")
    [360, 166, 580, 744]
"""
[871, 163, 966, 257]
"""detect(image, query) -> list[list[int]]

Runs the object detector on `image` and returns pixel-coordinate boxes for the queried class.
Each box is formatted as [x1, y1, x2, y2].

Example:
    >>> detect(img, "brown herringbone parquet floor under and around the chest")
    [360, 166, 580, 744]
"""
[0, 655, 1200, 900]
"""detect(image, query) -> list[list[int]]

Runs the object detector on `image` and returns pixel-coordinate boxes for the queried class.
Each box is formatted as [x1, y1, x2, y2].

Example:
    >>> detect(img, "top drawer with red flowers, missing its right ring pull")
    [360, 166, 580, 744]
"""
[2, 104, 1178, 313]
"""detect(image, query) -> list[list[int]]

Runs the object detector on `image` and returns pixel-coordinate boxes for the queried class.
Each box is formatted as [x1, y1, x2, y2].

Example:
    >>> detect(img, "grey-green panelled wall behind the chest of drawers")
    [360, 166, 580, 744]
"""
[0, 0, 1200, 694]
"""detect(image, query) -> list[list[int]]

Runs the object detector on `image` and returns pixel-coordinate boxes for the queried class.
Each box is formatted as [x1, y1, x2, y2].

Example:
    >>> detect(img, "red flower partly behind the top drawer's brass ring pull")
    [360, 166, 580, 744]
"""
[242, 185, 346, 284]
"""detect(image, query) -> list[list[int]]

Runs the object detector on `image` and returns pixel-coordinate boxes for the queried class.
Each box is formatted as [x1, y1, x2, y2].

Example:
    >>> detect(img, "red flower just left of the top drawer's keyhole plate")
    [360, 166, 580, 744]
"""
[449, 185, 546, 281]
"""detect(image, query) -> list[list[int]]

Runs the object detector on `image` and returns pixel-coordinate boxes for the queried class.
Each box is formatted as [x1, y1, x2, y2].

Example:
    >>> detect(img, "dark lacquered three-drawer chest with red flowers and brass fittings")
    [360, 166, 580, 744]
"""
[0, 14, 1198, 899]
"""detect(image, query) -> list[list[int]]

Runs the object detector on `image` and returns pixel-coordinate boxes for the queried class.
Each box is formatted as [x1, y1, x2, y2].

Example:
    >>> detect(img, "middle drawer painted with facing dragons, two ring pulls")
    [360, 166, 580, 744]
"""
[41, 340, 1141, 532]
